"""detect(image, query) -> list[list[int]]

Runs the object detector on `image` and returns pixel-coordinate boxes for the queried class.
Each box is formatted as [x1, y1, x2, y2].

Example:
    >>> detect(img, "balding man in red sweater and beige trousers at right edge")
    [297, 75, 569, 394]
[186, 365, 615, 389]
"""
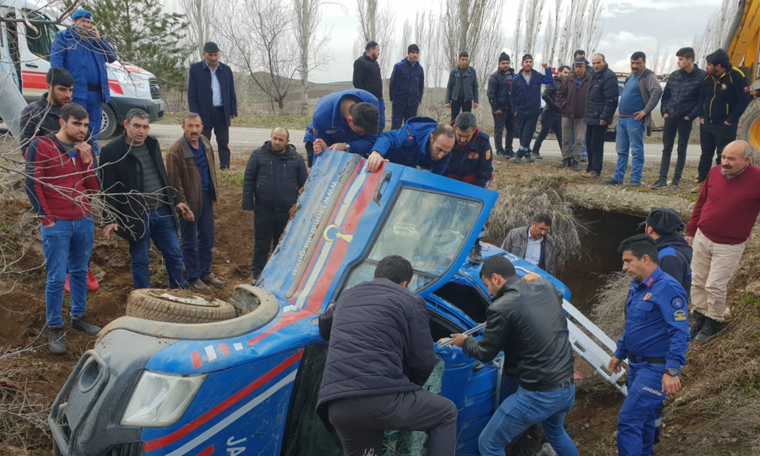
[686, 141, 760, 343]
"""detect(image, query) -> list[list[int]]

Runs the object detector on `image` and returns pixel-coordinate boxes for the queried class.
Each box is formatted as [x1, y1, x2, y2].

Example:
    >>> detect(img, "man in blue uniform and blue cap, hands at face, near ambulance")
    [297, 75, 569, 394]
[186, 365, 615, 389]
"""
[50, 9, 116, 151]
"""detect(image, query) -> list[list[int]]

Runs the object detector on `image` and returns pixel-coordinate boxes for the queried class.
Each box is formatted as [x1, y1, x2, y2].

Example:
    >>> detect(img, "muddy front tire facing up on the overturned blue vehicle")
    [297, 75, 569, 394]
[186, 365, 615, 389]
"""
[127, 288, 236, 323]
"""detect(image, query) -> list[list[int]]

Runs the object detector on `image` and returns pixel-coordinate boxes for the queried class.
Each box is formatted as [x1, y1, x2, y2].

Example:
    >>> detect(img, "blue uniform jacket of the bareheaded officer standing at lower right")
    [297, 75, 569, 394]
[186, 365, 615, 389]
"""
[615, 267, 689, 371]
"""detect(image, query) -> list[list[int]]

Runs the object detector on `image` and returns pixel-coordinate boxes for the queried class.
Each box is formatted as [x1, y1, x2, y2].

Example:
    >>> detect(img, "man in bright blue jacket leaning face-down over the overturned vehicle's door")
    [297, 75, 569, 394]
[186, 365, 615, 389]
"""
[367, 117, 455, 174]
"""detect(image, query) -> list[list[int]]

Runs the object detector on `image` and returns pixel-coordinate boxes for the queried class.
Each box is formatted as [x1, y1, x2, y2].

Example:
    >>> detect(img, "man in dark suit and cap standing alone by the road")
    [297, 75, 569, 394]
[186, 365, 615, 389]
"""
[187, 41, 237, 169]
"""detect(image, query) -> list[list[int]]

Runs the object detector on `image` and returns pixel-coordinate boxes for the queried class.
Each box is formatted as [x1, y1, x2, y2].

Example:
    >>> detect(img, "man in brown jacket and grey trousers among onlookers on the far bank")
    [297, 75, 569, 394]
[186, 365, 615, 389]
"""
[557, 57, 591, 171]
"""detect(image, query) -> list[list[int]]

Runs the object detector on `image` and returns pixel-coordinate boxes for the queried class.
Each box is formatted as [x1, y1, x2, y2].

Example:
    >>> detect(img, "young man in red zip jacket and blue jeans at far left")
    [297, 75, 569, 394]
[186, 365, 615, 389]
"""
[25, 103, 100, 354]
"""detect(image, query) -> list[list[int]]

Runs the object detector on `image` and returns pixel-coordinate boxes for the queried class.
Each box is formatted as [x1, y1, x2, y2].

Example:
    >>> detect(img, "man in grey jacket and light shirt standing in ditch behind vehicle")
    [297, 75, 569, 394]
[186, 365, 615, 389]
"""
[501, 214, 557, 275]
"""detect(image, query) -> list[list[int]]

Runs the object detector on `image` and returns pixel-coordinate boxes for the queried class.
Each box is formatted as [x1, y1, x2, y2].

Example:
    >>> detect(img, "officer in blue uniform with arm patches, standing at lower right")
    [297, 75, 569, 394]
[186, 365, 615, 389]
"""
[608, 234, 689, 456]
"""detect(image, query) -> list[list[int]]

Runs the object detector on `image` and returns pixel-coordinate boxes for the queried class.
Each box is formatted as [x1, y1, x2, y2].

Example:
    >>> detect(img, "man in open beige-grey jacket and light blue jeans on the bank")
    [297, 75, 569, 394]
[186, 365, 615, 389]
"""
[602, 51, 662, 187]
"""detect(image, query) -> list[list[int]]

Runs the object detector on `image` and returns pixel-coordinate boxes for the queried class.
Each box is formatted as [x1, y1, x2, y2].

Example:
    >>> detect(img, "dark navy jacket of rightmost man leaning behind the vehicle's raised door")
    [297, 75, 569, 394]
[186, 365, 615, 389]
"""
[446, 129, 493, 188]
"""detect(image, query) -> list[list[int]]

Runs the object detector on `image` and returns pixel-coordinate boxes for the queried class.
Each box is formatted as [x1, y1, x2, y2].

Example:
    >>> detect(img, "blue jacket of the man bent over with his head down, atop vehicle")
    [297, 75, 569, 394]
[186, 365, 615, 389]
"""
[303, 89, 380, 157]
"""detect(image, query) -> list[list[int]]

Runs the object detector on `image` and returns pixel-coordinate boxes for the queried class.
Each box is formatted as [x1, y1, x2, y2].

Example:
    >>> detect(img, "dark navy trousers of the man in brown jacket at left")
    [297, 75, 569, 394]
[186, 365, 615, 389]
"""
[179, 194, 214, 282]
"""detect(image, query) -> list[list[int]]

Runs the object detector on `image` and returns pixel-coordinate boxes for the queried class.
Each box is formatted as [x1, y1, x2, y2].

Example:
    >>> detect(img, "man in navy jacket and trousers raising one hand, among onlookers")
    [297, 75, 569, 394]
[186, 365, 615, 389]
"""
[511, 54, 552, 163]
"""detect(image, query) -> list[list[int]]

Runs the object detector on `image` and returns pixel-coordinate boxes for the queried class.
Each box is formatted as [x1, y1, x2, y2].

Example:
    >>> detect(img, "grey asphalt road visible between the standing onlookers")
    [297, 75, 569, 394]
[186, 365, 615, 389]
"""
[145, 124, 700, 165]
